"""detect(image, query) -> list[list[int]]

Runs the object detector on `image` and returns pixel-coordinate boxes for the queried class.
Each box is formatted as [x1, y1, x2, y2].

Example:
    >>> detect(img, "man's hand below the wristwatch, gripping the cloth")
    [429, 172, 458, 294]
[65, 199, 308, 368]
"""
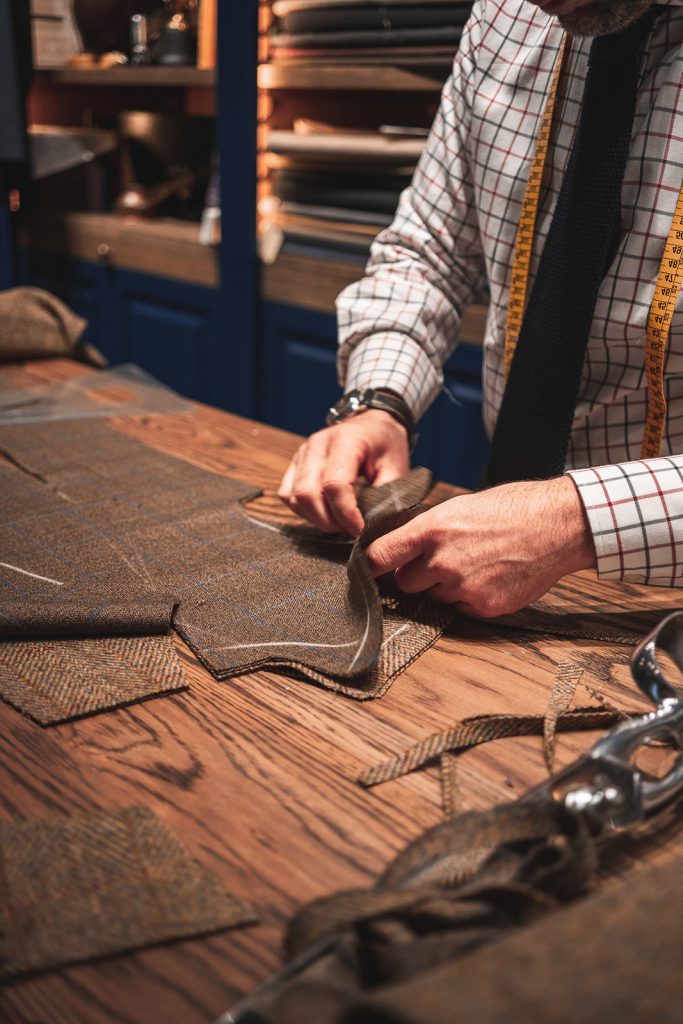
[278, 409, 410, 535]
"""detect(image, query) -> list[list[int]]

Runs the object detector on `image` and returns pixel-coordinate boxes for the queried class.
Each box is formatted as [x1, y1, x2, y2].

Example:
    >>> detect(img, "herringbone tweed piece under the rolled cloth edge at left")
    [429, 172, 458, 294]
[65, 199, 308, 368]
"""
[0, 636, 187, 725]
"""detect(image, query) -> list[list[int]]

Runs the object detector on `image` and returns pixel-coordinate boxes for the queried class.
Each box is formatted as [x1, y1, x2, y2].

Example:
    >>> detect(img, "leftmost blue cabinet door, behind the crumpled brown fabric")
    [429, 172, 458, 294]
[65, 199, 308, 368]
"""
[16, 249, 111, 362]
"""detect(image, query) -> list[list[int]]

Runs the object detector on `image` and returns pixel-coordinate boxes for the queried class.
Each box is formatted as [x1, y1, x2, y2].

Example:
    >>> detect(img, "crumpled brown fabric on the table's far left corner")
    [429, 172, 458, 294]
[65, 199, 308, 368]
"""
[0, 288, 106, 367]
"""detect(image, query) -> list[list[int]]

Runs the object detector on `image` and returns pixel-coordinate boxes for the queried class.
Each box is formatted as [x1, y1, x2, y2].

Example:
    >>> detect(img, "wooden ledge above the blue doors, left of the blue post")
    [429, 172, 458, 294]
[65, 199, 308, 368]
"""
[18, 213, 219, 288]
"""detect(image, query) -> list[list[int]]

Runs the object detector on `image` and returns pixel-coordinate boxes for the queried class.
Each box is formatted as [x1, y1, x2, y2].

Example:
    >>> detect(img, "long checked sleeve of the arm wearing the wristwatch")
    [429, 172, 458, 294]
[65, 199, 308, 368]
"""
[337, 2, 486, 420]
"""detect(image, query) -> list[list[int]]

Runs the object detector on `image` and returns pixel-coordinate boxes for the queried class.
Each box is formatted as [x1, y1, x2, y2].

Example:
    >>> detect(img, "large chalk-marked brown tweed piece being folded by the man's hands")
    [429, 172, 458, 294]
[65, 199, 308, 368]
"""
[0, 422, 444, 698]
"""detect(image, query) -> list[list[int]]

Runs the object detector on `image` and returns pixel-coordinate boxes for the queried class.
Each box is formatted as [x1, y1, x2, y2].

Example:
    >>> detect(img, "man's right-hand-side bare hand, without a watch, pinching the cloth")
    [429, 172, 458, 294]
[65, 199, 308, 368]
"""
[366, 476, 595, 618]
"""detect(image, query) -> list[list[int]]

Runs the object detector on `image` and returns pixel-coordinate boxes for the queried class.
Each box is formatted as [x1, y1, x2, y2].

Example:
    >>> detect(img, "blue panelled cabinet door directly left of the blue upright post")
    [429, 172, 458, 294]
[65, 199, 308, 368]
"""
[112, 270, 216, 401]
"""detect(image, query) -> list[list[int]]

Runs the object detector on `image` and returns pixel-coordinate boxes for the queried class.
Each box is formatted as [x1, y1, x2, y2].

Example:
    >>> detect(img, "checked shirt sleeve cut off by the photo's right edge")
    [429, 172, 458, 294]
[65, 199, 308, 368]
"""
[567, 456, 683, 587]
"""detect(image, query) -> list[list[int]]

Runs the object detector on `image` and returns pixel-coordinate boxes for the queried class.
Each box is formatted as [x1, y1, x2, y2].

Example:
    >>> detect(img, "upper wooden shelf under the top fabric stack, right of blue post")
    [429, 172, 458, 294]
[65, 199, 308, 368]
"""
[258, 63, 446, 92]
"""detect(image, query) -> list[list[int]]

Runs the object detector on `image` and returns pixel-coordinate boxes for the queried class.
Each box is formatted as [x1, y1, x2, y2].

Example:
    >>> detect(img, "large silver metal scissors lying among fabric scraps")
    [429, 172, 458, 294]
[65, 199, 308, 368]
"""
[215, 611, 683, 1024]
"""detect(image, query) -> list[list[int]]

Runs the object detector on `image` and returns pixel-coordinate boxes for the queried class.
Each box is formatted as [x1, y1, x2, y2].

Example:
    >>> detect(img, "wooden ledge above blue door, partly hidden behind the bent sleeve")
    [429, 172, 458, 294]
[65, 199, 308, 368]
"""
[261, 253, 486, 345]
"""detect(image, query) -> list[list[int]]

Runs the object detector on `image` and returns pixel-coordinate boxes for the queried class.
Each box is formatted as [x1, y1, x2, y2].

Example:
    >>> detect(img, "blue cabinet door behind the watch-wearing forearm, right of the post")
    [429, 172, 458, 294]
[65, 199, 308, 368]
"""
[257, 303, 487, 487]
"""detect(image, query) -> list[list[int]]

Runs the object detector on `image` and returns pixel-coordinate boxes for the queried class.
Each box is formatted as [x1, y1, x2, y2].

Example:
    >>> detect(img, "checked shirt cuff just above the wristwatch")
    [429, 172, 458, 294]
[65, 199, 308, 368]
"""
[340, 332, 443, 423]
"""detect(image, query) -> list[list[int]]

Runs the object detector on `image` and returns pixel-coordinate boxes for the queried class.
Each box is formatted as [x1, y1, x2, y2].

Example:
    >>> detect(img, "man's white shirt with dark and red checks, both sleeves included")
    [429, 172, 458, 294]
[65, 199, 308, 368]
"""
[338, 0, 683, 586]
